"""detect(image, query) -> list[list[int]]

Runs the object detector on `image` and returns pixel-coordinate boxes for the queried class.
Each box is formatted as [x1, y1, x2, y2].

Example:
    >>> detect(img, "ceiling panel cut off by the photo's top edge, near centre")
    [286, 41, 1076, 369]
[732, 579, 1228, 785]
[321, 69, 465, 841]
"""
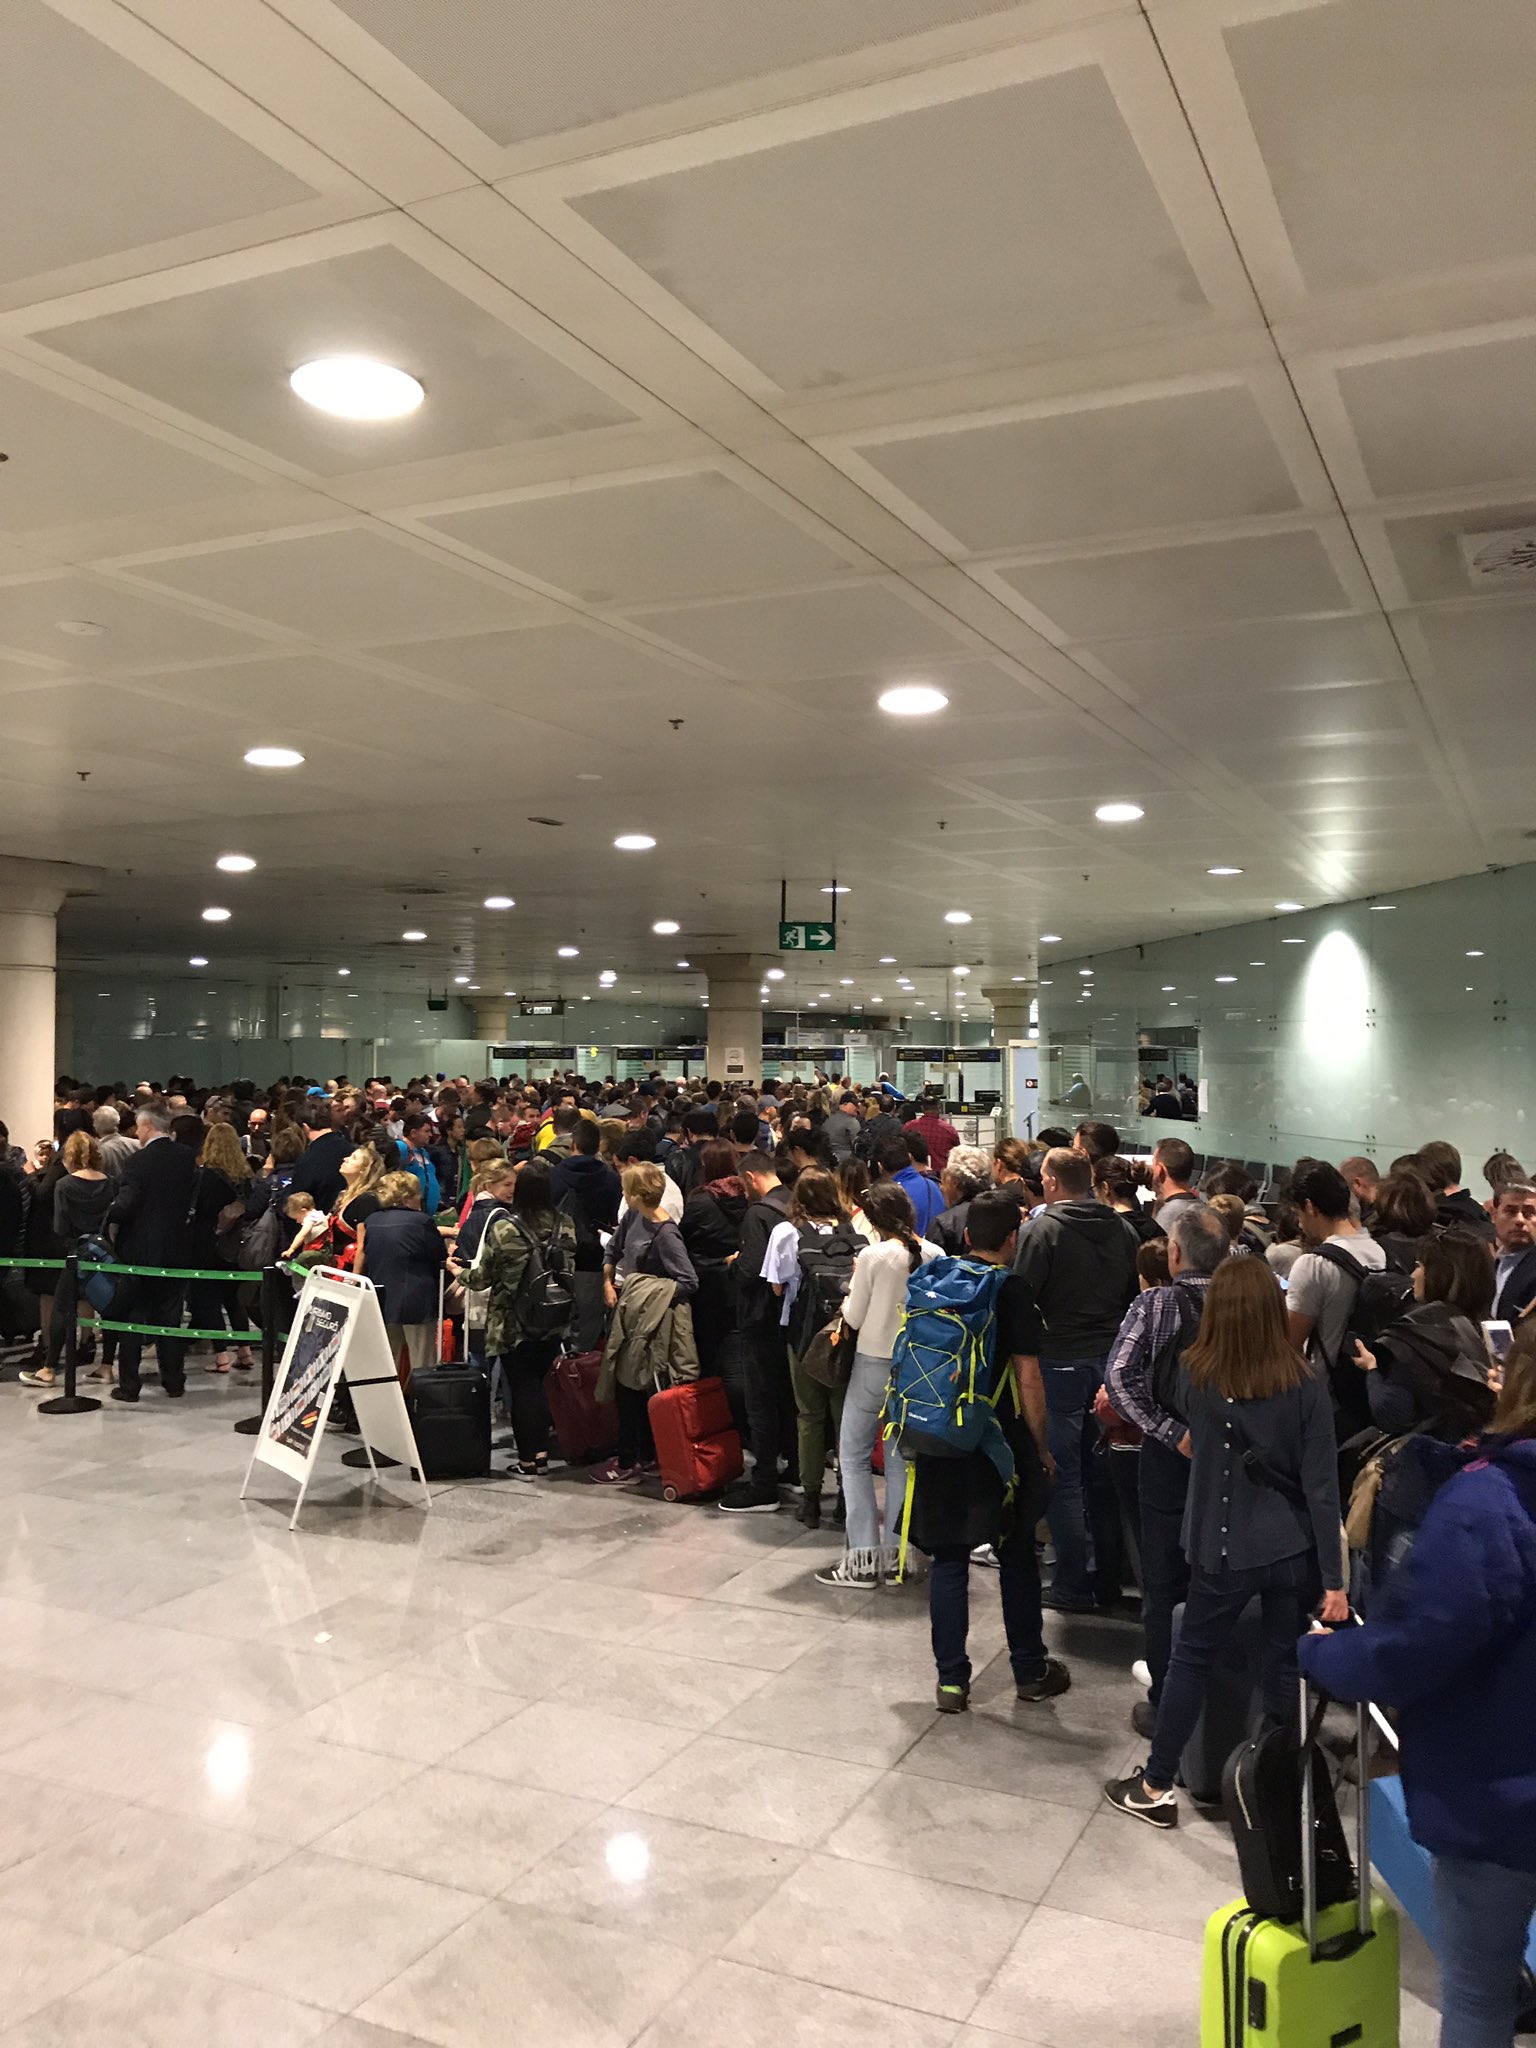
[336, 0, 1040, 143]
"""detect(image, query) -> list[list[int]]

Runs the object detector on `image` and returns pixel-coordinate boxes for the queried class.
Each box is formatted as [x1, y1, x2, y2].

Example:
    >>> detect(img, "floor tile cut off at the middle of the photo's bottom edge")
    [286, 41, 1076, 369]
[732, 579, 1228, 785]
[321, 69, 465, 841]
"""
[635, 1962, 958, 2048]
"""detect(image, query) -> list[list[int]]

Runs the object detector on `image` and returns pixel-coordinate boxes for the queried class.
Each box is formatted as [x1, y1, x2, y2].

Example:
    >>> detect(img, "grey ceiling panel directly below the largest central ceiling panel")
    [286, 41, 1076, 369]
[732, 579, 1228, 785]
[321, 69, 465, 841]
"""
[858, 385, 1298, 551]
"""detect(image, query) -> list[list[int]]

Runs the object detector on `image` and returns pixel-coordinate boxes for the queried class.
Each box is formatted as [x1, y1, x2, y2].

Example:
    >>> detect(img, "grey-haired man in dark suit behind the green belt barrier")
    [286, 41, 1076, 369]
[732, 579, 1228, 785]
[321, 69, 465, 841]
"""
[106, 1104, 197, 1401]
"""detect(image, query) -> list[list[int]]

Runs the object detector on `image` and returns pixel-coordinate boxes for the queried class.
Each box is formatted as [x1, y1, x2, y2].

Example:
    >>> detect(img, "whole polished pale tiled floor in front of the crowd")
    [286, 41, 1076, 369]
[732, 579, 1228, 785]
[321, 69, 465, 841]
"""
[0, 1374, 1436, 2048]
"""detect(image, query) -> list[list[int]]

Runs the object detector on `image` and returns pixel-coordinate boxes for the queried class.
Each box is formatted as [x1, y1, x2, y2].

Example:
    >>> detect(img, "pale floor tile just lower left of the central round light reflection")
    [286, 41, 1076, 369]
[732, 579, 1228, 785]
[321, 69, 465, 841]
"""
[154, 1849, 479, 2013]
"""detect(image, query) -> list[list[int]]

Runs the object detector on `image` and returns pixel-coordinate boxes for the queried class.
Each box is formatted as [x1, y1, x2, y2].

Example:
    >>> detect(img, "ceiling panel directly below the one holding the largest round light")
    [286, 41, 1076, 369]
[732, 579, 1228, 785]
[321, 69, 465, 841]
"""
[125, 528, 552, 645]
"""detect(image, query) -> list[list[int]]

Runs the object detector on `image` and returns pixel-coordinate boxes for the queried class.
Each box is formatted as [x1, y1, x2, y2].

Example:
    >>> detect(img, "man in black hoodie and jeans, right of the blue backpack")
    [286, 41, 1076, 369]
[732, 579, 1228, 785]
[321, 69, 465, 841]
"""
[1014, 1147, 1137, 1614]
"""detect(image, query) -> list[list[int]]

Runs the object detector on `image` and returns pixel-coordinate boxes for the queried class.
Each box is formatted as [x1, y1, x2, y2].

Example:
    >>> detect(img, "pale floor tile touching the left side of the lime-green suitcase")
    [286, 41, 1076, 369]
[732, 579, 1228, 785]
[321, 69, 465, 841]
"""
[969, 1907, 1200, 2048]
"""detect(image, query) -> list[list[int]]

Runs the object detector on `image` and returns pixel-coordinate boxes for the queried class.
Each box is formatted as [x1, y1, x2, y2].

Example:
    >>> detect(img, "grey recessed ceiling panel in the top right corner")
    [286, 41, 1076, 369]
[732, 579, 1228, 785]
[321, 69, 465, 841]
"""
[1227, 0, 1536, 291]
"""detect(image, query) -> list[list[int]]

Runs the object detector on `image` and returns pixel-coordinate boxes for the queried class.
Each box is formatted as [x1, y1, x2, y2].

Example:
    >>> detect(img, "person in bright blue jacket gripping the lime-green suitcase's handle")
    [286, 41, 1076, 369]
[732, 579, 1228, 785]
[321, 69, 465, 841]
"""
[1300, 1321, 1536, 2048]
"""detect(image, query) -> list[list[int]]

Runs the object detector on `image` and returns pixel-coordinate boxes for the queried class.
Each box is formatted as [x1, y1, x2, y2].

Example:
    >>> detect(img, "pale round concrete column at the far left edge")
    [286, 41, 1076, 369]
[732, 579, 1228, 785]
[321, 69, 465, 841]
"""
[0, 856, 98, 1151]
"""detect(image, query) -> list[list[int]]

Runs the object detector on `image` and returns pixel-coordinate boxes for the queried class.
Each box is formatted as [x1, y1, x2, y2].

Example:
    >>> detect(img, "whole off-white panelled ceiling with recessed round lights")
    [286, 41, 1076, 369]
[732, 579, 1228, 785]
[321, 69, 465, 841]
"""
[0, 0, 1536, 1001]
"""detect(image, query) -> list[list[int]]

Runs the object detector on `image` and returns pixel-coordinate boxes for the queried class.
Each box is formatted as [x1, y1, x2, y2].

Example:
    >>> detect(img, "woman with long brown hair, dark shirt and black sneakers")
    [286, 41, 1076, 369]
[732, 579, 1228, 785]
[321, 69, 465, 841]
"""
[1104, 1260, 1350, 1827]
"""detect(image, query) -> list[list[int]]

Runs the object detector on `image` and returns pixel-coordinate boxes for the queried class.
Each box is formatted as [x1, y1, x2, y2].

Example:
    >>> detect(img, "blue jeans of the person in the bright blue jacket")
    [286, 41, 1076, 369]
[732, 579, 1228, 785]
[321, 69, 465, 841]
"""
[1436, 1855, 1536, 2048]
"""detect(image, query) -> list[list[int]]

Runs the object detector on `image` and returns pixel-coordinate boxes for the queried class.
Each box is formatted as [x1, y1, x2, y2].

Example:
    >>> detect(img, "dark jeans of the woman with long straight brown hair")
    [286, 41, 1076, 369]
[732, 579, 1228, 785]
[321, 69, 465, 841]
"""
[1147, 1550, 1317, 1792]
